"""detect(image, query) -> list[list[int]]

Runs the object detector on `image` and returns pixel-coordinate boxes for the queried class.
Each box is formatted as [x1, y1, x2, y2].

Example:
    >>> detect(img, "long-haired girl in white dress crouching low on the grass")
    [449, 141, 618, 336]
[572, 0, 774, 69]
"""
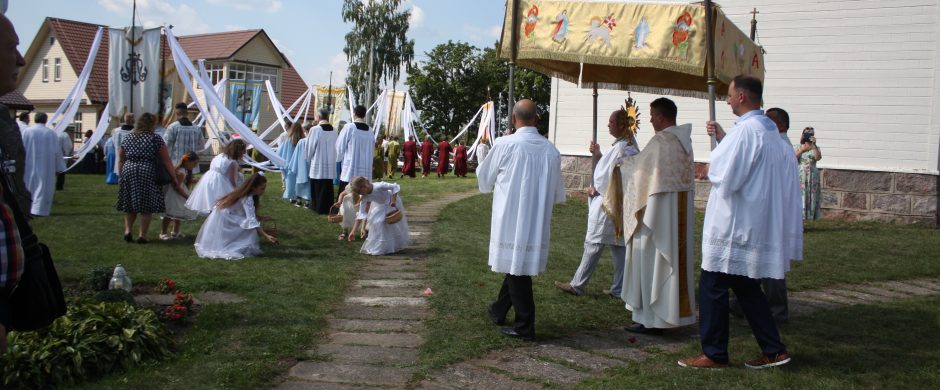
[195, 173, 277, 260]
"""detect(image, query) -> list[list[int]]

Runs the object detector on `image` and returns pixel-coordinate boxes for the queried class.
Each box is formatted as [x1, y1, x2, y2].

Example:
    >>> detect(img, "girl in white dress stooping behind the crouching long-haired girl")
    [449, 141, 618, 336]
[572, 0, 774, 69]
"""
[186, 139, 248, 215]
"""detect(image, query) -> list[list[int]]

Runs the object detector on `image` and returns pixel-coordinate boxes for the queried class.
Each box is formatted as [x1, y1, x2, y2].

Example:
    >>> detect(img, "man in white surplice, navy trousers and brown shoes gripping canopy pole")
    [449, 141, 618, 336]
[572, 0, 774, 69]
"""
[679, 75, 803, 368]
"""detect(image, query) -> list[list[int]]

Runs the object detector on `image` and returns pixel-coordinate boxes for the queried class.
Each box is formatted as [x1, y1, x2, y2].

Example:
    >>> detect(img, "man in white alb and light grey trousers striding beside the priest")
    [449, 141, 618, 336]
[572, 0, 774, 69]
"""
[555, 109, 639, 298]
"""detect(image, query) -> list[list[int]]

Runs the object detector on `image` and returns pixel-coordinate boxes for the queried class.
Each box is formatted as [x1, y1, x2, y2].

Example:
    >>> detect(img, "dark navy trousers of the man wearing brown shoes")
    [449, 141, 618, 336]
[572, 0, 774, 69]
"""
[699, 270, 787, 363]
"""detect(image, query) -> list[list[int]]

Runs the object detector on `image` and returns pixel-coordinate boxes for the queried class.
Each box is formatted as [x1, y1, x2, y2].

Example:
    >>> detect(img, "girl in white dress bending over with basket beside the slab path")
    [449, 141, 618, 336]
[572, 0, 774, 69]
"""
[349, 176, 411, 256]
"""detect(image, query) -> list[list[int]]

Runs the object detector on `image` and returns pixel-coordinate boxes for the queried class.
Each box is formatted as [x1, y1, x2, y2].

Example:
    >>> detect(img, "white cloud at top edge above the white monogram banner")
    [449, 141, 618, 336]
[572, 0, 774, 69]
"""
[98, 0, 209, 34]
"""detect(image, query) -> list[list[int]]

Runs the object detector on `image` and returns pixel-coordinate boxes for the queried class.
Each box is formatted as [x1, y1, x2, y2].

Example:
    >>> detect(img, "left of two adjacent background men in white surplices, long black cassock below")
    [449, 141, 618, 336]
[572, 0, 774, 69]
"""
[305, 108, 337, 214]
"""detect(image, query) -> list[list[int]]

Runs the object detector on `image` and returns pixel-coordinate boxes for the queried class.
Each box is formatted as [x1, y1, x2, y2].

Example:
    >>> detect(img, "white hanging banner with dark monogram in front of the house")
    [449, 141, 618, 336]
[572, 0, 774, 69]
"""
[108, 27, 160, 116]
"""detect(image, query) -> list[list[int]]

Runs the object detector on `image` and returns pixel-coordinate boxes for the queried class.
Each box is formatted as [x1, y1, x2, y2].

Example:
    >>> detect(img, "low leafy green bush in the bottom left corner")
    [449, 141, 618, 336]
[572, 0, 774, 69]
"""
[0, 303, 172, 389]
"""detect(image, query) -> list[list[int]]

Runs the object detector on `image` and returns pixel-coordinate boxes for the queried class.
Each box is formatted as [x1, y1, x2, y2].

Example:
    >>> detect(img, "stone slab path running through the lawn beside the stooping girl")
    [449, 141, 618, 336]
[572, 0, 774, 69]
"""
[276, 191, 479, 389]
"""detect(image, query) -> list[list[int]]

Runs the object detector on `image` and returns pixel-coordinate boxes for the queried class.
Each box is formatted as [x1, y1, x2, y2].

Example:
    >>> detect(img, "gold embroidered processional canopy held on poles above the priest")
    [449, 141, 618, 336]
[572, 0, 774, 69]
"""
[500, 0, 764, 97]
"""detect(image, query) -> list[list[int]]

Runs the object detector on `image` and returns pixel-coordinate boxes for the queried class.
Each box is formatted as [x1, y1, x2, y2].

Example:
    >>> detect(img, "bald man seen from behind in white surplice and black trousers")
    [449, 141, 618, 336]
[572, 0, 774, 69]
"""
[477, 99, 565, 340]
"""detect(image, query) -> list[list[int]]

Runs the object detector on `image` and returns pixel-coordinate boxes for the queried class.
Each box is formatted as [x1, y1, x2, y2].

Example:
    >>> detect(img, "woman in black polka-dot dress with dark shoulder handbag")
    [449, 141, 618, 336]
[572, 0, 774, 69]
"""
[117, 112, 186, 244]
